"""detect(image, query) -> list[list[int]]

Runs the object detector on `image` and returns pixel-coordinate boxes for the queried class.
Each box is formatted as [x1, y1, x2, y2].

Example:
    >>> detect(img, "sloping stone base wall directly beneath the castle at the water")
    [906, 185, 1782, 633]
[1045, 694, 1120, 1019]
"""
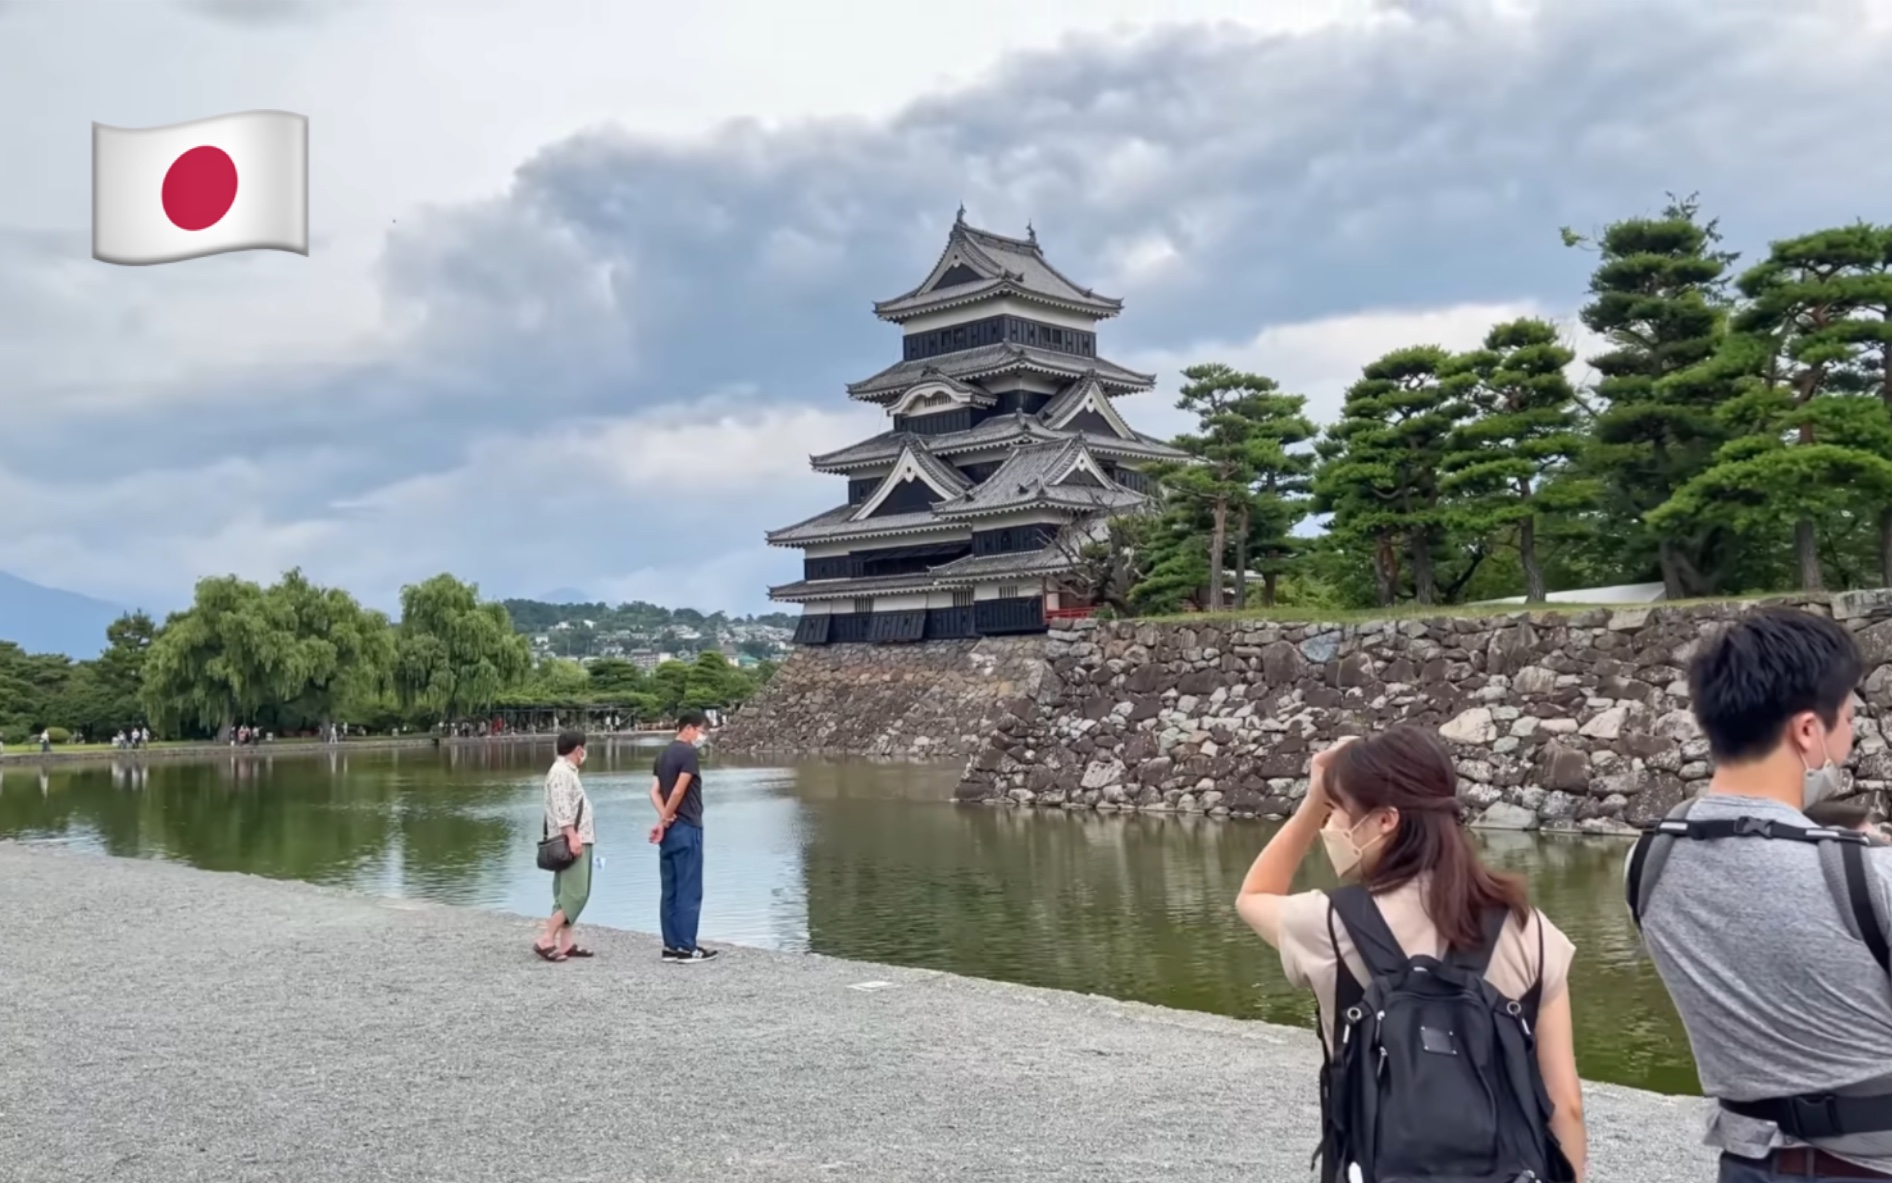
[715, 636, 1050, 761]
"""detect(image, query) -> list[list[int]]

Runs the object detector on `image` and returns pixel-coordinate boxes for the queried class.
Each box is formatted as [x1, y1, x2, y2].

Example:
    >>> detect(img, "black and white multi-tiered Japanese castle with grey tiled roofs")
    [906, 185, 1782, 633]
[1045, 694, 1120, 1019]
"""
[768, 208, 1183, 645]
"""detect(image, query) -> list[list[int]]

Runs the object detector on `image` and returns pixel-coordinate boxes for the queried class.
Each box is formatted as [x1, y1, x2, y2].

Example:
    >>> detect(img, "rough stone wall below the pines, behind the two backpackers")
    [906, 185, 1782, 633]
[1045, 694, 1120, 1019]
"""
[957, 591, 1892, 833]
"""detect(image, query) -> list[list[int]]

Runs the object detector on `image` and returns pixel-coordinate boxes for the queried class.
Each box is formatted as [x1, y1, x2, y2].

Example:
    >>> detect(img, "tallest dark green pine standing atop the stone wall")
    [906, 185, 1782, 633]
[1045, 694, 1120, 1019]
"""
[1565, 197, 1737, 600]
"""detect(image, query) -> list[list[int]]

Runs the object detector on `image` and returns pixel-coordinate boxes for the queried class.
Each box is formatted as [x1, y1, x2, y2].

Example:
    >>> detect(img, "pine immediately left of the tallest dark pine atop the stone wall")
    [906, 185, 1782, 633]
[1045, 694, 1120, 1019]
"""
[1442, 318, 1595, 604]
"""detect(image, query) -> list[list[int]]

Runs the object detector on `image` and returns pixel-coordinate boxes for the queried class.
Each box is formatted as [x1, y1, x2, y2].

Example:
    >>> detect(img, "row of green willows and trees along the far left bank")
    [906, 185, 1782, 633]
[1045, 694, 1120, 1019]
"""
[0, 570, 776, 744]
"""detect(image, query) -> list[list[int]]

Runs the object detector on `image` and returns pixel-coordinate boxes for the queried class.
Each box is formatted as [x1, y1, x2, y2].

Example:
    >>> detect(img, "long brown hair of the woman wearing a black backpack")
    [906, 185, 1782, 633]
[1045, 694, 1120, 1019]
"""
[1330, 727, 1531, 948]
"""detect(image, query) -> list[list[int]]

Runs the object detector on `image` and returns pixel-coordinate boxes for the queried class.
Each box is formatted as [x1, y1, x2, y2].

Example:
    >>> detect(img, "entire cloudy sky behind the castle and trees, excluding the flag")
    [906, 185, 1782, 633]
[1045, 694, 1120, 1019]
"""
[0, 0, 1892, 611]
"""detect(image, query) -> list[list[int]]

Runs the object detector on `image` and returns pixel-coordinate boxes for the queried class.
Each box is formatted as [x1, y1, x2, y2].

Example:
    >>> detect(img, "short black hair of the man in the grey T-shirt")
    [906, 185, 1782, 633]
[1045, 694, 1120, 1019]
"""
[1688, 608, 1866, 763]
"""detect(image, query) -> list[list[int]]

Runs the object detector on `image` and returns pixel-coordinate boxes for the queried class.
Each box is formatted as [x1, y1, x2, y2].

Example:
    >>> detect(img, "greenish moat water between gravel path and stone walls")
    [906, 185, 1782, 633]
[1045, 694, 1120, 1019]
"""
[0, 744, 1697, 1092]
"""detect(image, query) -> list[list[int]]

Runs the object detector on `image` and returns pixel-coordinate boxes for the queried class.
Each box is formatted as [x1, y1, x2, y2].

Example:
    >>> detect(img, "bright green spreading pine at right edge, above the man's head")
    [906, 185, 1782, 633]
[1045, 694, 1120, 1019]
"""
[1650, 225, 1892, 591]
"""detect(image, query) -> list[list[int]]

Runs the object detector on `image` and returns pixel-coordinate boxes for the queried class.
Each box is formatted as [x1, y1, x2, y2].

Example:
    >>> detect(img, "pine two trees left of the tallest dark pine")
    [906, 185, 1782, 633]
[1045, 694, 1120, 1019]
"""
[1313, 344, 1459, 608]
